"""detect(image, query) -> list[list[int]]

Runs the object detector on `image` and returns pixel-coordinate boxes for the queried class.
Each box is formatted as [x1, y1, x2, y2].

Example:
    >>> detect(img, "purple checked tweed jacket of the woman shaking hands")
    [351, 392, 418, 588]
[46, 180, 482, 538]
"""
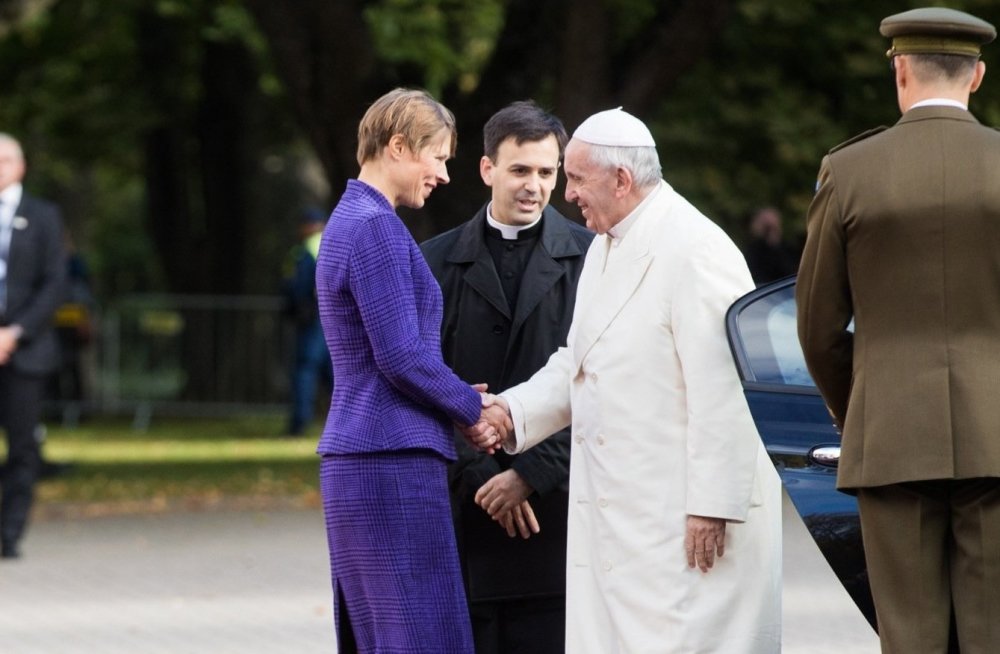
[316, 179, 480, 460]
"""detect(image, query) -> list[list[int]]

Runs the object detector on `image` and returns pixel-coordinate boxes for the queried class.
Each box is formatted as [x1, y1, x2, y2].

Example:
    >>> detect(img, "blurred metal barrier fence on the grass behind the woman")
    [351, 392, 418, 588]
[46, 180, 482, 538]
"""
[55, 295, 294, 426]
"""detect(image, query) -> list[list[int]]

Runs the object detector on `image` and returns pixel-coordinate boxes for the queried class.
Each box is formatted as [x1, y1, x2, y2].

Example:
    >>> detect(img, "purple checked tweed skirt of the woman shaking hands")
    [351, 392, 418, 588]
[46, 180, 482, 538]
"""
[320, 450, 474, 654]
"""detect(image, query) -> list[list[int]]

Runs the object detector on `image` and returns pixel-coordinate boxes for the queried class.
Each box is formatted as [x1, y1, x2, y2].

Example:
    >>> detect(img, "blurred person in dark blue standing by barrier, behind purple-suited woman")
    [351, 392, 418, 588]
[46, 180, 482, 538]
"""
[284, 207, 333, 436]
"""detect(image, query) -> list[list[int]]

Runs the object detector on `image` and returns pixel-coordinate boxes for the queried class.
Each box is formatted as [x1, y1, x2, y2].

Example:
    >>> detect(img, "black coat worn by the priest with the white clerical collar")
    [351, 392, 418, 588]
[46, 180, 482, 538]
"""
[421, 206, 594, 601]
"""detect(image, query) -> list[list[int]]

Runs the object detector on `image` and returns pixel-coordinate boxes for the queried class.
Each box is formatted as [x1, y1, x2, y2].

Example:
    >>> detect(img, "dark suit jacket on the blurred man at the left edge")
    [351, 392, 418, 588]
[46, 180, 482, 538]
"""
[2, 193, 66, 375]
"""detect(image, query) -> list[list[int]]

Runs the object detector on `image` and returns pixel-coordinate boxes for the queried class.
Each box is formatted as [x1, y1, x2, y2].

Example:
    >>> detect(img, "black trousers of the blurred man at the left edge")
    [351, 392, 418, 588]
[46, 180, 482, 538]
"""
[0, 365, 45, 543]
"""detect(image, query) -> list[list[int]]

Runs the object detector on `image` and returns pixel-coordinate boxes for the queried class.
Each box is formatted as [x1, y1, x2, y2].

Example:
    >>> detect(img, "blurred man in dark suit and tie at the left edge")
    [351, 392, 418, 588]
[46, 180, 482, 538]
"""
[0, 134, 66, 559]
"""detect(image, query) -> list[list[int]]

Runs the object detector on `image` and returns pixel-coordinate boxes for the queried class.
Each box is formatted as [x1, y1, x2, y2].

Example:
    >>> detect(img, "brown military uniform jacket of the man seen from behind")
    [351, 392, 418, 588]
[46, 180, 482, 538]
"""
[797, 107, 1000, 488]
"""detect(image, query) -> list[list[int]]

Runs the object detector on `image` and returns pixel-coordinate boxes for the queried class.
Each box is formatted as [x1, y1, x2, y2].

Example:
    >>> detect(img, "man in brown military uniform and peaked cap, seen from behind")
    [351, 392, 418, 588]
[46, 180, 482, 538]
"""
[797, 8, 1000, 654]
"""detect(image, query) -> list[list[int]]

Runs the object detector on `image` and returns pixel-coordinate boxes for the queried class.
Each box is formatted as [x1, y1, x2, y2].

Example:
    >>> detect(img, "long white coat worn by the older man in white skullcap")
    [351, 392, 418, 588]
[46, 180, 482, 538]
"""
[502, 182, 781, 654]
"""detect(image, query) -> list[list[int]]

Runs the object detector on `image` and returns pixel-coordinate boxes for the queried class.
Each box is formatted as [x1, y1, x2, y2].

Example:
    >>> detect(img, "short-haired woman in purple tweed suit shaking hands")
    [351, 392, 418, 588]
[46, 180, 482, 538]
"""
[316, 89, 492, 654]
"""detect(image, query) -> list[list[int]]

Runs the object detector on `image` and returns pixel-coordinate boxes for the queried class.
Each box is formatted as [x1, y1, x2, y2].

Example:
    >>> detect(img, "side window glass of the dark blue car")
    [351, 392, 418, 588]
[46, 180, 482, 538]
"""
[737, 286, 815, 387]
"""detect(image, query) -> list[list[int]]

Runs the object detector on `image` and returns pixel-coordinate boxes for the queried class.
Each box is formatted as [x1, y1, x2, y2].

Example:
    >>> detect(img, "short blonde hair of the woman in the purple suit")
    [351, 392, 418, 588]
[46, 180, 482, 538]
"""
[358, 89, 458, 165]
